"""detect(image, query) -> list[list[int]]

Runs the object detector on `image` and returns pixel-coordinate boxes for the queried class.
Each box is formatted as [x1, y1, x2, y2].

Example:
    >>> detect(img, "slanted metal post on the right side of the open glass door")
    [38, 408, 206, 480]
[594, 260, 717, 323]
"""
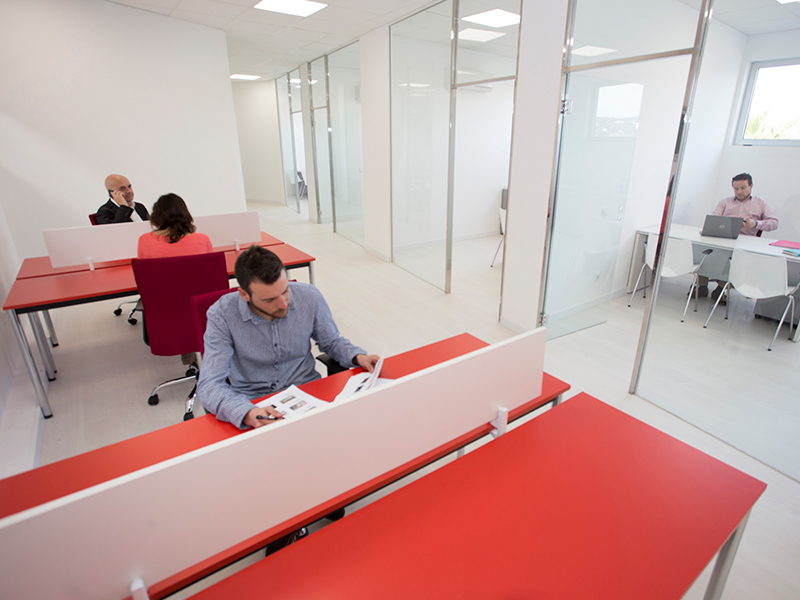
[628, 0, 713, 394]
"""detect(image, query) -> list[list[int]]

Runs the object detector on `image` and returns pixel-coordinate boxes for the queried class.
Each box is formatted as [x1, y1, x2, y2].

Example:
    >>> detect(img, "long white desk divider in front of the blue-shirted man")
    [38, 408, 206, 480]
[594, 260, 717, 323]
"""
[0, 328, 545, 600]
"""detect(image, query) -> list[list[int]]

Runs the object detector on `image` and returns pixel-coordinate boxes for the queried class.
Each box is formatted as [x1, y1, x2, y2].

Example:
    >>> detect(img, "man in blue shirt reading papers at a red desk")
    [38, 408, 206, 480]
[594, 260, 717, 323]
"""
[197, 246, 378, 429]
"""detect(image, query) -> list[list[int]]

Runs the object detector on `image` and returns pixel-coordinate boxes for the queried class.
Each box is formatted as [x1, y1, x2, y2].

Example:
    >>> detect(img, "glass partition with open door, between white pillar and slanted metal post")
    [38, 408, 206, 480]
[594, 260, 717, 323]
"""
[541, 0, 698, 339]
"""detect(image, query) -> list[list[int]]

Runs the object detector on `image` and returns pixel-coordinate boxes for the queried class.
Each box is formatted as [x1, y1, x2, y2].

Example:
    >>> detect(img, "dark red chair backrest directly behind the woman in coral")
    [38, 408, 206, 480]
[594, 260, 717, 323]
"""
[131, 252, 228, 356]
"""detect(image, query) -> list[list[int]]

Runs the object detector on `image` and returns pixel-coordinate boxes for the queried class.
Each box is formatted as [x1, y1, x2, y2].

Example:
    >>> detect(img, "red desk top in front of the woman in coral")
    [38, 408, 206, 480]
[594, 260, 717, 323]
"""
[3, 244, 314, 312]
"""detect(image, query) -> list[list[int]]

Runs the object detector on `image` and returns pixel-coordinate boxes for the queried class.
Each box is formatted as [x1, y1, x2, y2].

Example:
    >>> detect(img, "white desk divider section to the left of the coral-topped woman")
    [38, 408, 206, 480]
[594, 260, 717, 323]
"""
[42, 221, 152, 270]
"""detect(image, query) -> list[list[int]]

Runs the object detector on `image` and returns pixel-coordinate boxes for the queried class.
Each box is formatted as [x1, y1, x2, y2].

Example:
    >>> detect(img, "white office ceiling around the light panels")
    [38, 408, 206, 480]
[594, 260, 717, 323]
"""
[110, 0, 800, 79]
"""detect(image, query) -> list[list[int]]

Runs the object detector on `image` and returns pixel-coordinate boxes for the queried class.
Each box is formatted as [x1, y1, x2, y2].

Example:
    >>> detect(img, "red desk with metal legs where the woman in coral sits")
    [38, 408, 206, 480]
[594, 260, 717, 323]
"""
[3, 239, 314, 418]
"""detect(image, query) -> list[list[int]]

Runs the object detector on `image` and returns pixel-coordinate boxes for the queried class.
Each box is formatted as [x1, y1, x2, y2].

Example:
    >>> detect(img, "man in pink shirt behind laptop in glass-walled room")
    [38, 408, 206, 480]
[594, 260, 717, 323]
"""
[698, 173, 778, 300]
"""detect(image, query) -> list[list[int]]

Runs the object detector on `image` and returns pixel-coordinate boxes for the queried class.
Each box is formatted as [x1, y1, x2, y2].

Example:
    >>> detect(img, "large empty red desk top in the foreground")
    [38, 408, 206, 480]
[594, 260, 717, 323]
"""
[193, 394, 766, 600]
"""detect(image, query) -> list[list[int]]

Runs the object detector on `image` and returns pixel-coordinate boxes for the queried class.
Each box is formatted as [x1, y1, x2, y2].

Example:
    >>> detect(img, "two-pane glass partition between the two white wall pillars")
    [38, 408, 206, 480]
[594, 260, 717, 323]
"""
[391, 0, 520, 298]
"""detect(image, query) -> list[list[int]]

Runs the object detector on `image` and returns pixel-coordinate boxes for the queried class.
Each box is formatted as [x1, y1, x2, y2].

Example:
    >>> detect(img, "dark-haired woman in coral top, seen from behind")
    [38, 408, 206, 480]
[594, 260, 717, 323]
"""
[137, 194, 213, 258]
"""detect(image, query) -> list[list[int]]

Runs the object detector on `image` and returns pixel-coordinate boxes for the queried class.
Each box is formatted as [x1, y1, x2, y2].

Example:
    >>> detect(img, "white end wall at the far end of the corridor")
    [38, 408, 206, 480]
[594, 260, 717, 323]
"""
[232, 79, 285, 203]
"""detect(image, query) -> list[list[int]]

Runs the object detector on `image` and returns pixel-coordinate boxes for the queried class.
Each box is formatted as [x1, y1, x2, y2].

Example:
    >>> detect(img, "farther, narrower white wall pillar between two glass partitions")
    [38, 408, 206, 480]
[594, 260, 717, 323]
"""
[359, 26, 392, 260]
